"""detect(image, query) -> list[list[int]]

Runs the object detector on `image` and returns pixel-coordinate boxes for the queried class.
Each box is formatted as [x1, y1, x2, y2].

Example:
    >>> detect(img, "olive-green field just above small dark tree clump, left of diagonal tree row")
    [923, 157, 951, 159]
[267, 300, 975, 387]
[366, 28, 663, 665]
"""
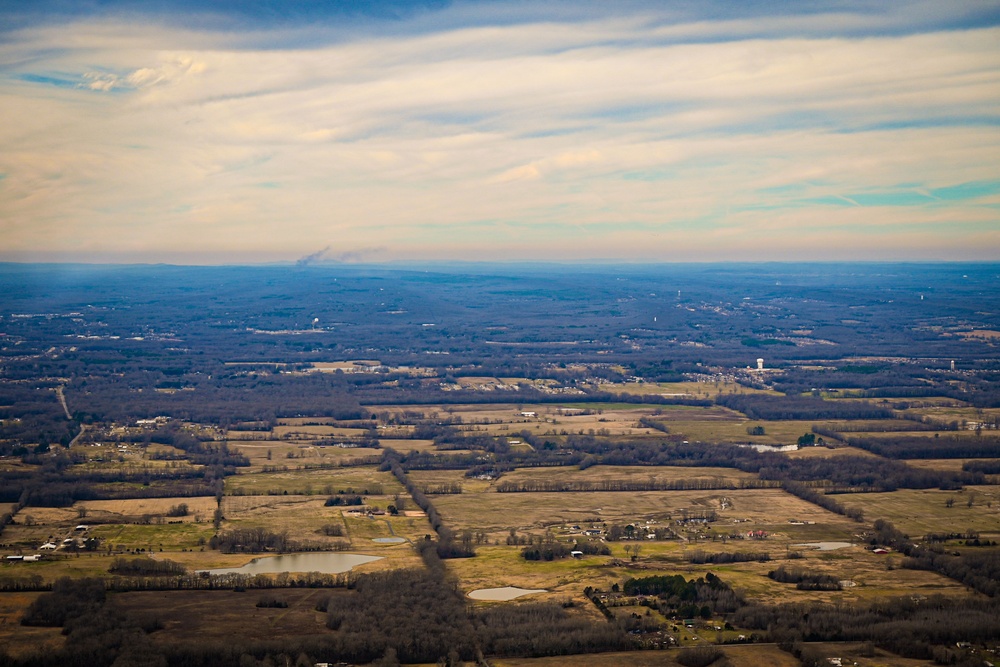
[226, 467, 403, 495]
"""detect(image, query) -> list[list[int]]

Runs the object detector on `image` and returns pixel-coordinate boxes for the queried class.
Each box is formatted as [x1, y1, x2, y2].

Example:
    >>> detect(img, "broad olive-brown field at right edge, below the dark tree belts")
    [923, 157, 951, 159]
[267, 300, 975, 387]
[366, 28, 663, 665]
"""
[837, 486, 1000, 539]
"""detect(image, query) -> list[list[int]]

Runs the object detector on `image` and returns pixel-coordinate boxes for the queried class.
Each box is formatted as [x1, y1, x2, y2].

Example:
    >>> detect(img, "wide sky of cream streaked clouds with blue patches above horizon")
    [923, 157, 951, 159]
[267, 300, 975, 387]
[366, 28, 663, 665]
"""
[0, 0, 1000, 264]
